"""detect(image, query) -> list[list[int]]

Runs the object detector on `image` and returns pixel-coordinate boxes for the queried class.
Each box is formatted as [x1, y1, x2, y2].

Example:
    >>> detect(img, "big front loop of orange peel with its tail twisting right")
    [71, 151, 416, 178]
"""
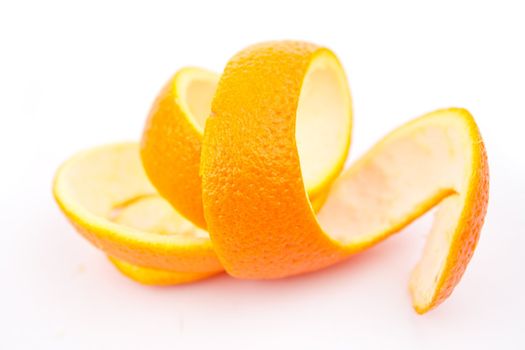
[201, 42, 488, 312]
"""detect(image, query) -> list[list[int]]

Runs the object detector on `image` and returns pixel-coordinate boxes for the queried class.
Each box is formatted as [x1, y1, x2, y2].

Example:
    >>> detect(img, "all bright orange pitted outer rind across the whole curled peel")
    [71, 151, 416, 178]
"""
[52, 42, 489, 313]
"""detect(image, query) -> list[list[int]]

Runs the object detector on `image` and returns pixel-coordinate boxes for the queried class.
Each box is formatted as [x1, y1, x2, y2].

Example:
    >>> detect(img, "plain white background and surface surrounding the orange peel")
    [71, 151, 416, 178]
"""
[0, 0, 525, 349]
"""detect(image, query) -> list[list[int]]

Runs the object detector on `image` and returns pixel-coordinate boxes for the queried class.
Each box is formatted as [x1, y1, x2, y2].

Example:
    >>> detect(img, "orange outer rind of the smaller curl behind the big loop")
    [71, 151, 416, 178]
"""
[141, 74, 206, 228]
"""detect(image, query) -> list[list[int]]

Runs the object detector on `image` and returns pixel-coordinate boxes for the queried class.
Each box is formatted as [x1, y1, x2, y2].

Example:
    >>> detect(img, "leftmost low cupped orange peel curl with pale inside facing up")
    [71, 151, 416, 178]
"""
[53, 142, 223, 283]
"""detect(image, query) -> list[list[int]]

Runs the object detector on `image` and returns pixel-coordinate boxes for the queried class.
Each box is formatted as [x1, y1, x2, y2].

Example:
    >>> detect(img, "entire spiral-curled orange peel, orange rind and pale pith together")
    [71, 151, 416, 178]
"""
[54, 41, 489, 313]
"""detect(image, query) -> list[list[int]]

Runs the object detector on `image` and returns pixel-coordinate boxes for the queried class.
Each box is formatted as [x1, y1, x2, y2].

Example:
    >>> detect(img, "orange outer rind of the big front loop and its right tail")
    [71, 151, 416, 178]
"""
[201, 42, 488, 312]
